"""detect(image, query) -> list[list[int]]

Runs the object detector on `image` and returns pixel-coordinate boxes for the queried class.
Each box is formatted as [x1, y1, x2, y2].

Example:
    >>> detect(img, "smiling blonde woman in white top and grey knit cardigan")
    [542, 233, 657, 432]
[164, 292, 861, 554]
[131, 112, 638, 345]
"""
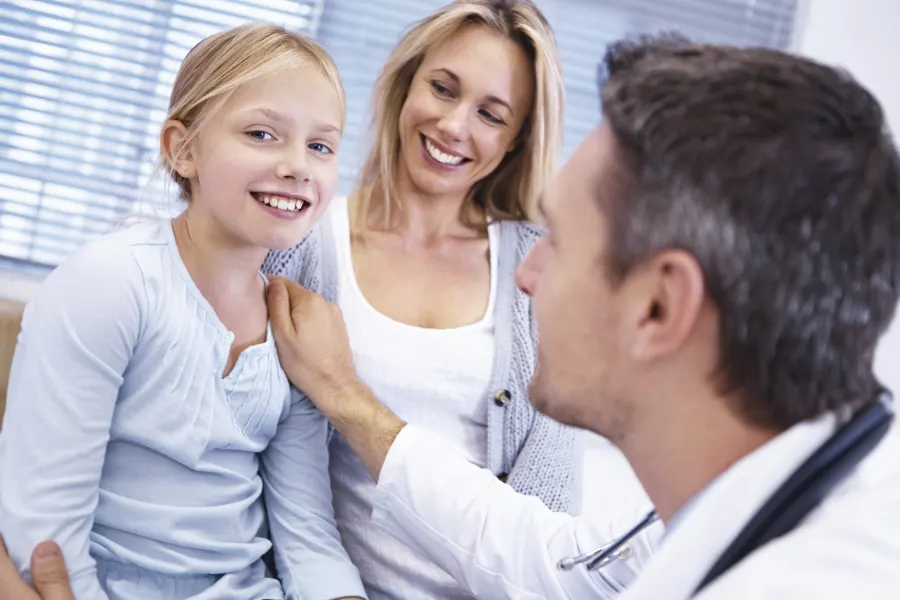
[263, 0, 574, 600]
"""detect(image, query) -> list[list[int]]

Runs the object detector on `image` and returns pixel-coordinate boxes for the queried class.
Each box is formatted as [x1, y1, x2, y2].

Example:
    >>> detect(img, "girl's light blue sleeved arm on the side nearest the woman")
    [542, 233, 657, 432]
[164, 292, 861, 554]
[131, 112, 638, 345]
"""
[261, 386, 365, 600]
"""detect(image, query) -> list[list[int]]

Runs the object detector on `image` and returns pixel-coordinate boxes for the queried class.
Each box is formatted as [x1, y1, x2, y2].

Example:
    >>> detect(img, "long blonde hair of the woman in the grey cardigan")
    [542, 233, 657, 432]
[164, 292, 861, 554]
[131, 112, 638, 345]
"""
[356, 0, 565, 225]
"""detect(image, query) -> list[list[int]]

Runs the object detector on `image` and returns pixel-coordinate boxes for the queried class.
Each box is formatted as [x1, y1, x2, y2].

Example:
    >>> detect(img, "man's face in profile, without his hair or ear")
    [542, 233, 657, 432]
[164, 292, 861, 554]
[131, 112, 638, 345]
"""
[517, 126, 624, 433]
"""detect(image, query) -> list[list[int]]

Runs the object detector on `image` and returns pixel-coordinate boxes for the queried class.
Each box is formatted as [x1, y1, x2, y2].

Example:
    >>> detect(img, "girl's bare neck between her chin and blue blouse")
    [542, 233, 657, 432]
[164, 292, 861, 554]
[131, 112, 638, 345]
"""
[172, 208, 268, 306]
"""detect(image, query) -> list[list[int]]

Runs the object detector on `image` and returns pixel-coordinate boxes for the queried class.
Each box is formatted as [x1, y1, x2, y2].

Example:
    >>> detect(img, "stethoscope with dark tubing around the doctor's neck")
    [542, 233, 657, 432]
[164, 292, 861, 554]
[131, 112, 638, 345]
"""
[556, 390, 894, 591]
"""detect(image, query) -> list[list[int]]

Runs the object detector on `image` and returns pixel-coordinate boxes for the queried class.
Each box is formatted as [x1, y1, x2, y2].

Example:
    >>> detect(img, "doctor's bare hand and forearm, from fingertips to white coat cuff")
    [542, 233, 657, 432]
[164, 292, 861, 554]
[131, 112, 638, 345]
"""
[268, 277, 405, 478]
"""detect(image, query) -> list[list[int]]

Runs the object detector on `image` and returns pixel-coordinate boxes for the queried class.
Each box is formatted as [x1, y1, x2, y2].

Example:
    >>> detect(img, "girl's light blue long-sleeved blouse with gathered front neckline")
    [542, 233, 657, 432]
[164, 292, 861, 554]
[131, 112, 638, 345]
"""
[0, 221, 363, 600]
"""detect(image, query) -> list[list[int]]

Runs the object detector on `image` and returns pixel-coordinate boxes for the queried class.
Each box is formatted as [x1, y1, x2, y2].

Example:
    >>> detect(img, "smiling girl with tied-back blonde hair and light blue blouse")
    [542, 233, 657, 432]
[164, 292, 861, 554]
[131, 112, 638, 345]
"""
[0, 25, 363, 600]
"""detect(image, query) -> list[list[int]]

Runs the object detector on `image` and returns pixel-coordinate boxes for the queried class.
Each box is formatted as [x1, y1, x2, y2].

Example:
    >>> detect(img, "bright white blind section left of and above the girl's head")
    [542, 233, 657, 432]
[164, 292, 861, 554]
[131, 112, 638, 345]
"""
[0, 0, 322, 266]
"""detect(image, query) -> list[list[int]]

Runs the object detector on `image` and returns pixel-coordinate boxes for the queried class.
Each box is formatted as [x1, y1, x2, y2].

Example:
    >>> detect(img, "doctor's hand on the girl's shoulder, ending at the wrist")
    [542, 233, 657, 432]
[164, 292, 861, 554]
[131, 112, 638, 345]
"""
[267, 277, 358, 414]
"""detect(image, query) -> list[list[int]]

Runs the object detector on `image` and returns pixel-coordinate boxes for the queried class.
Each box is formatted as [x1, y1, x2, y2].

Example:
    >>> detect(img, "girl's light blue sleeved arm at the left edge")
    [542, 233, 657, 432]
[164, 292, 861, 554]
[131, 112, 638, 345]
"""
[0, 239, 144, 600]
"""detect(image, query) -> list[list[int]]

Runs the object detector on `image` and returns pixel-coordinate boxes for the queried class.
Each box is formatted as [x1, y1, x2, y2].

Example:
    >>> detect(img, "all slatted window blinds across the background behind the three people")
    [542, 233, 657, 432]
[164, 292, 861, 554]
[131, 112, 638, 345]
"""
[0, 0, 796, 267]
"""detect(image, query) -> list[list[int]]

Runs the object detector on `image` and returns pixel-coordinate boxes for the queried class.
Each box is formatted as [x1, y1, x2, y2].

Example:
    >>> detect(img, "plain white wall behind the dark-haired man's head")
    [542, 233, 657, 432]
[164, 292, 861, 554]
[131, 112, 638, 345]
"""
[794, 0, 900, 395]
